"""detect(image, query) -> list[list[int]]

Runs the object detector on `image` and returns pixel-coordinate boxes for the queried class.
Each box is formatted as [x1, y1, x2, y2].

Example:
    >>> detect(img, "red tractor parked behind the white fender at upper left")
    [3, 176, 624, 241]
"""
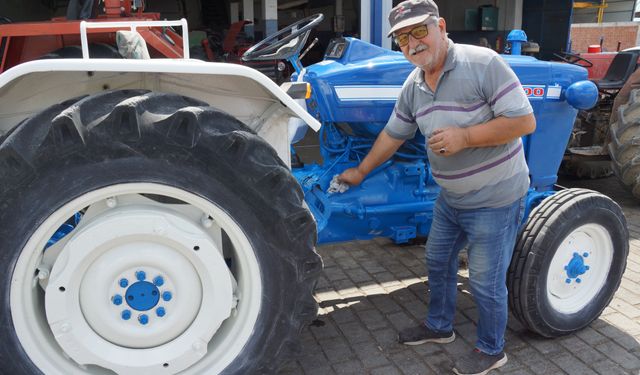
[0, 0, 291, 83]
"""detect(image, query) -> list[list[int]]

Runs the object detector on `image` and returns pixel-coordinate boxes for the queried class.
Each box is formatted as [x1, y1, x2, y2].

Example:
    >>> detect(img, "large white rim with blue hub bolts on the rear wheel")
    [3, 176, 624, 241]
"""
[10, 183, 262, 375]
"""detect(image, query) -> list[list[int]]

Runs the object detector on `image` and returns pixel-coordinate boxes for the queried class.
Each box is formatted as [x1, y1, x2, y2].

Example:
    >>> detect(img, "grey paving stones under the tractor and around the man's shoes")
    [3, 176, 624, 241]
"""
[280, 178, 640, 375]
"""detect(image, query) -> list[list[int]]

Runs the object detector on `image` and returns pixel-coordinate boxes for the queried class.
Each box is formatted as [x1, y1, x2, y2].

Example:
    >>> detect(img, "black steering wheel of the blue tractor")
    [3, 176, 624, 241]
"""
[242, 13, 324, 61]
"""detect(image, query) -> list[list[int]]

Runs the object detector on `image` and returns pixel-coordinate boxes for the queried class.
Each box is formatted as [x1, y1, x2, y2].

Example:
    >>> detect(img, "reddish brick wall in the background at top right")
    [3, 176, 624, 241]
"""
[571, 22, 640, 52]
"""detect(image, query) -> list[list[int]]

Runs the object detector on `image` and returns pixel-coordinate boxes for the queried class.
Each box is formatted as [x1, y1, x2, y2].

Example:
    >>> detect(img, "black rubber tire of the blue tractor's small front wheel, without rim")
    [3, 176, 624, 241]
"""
[507, 189, 629, 337]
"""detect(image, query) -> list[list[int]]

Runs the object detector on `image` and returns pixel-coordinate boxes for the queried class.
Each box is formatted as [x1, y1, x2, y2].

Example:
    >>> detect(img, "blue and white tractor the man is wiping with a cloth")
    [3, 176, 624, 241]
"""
[0, 5, 629, 375]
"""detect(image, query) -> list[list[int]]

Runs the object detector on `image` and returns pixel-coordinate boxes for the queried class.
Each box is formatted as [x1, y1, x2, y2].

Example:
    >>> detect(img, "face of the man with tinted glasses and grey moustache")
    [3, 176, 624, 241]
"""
[394, 19, 446, 71]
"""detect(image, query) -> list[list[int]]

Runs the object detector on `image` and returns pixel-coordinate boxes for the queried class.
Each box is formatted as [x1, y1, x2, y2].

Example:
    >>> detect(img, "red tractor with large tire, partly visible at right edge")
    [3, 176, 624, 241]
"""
[558, 49, 640, 198]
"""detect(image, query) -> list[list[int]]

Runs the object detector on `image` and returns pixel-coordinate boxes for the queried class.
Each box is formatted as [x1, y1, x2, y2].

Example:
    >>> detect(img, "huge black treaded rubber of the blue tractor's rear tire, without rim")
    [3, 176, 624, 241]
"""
[0, 90, 322, 375]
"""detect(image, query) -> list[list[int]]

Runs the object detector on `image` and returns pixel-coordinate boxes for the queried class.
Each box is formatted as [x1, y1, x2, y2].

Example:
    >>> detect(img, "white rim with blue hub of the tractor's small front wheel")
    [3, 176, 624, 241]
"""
[547, 224, 614, 314]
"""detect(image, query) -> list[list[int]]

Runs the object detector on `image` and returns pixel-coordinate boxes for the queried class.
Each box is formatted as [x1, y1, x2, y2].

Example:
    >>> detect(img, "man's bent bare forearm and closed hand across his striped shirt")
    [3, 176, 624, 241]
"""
[428, 113, 536, 156]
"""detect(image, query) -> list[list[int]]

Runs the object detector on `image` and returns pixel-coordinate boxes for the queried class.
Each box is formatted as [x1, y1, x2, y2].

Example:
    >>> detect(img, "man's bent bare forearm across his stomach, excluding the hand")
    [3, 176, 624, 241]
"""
[466, 114, 536, 147]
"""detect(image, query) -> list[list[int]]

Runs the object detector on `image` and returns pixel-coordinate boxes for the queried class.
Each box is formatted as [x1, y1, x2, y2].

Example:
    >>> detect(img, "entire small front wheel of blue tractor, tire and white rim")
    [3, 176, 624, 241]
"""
[507, 189, 629, 337]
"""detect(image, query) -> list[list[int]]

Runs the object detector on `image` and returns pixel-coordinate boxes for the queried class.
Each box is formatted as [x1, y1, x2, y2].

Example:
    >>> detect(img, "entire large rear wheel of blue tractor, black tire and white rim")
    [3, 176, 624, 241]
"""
[0, 90, 322, 375]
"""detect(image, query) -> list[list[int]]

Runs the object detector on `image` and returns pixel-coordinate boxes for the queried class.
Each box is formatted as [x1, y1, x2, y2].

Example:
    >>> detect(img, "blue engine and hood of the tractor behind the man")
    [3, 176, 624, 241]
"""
[294, 38, 597, 243]
